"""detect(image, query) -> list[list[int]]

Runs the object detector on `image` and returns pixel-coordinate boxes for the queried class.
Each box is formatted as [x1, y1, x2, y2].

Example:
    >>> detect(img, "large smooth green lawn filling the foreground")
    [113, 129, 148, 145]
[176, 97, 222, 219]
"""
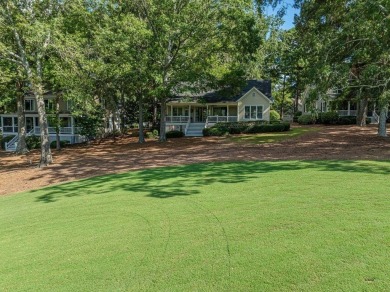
[0, 161, 390, 291]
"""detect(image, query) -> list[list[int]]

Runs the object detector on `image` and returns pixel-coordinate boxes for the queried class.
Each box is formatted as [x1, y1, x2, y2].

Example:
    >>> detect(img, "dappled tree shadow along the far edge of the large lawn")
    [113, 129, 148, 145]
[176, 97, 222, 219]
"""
[31, 160, 390, 203]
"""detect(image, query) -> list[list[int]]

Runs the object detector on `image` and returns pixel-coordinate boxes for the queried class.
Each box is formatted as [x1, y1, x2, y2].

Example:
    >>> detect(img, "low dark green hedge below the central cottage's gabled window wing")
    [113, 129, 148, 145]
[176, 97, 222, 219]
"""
[203, 121, 290, 136]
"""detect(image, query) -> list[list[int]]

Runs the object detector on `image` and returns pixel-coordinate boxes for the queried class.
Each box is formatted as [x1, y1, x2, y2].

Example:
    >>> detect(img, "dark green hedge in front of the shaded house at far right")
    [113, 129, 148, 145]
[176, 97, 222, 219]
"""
[298, 112, 371, 125]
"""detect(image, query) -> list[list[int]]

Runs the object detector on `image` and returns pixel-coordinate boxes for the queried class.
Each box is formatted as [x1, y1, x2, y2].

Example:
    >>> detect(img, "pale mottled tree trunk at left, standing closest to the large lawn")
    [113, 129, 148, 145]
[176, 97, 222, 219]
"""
[34, 90, 53, 167]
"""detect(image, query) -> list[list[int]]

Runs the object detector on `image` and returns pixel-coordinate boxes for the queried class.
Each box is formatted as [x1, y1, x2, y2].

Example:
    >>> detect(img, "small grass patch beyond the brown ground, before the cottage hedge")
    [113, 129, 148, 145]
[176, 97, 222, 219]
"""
[228, 127, 318, 144]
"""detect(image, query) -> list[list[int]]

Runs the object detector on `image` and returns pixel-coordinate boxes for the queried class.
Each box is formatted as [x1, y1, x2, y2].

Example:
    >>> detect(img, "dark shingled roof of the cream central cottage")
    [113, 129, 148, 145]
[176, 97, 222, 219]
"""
[175, 80, 273, 103]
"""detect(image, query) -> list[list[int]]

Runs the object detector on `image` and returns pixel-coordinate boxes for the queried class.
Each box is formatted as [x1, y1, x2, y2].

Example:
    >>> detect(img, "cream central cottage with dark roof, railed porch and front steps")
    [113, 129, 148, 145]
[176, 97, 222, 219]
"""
[166, 80, 273, 136]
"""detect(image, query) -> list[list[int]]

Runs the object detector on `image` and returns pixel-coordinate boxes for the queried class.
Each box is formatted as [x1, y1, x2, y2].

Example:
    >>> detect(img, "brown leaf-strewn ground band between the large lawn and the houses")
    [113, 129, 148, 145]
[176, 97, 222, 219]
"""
[0, 125, 390, 195]
